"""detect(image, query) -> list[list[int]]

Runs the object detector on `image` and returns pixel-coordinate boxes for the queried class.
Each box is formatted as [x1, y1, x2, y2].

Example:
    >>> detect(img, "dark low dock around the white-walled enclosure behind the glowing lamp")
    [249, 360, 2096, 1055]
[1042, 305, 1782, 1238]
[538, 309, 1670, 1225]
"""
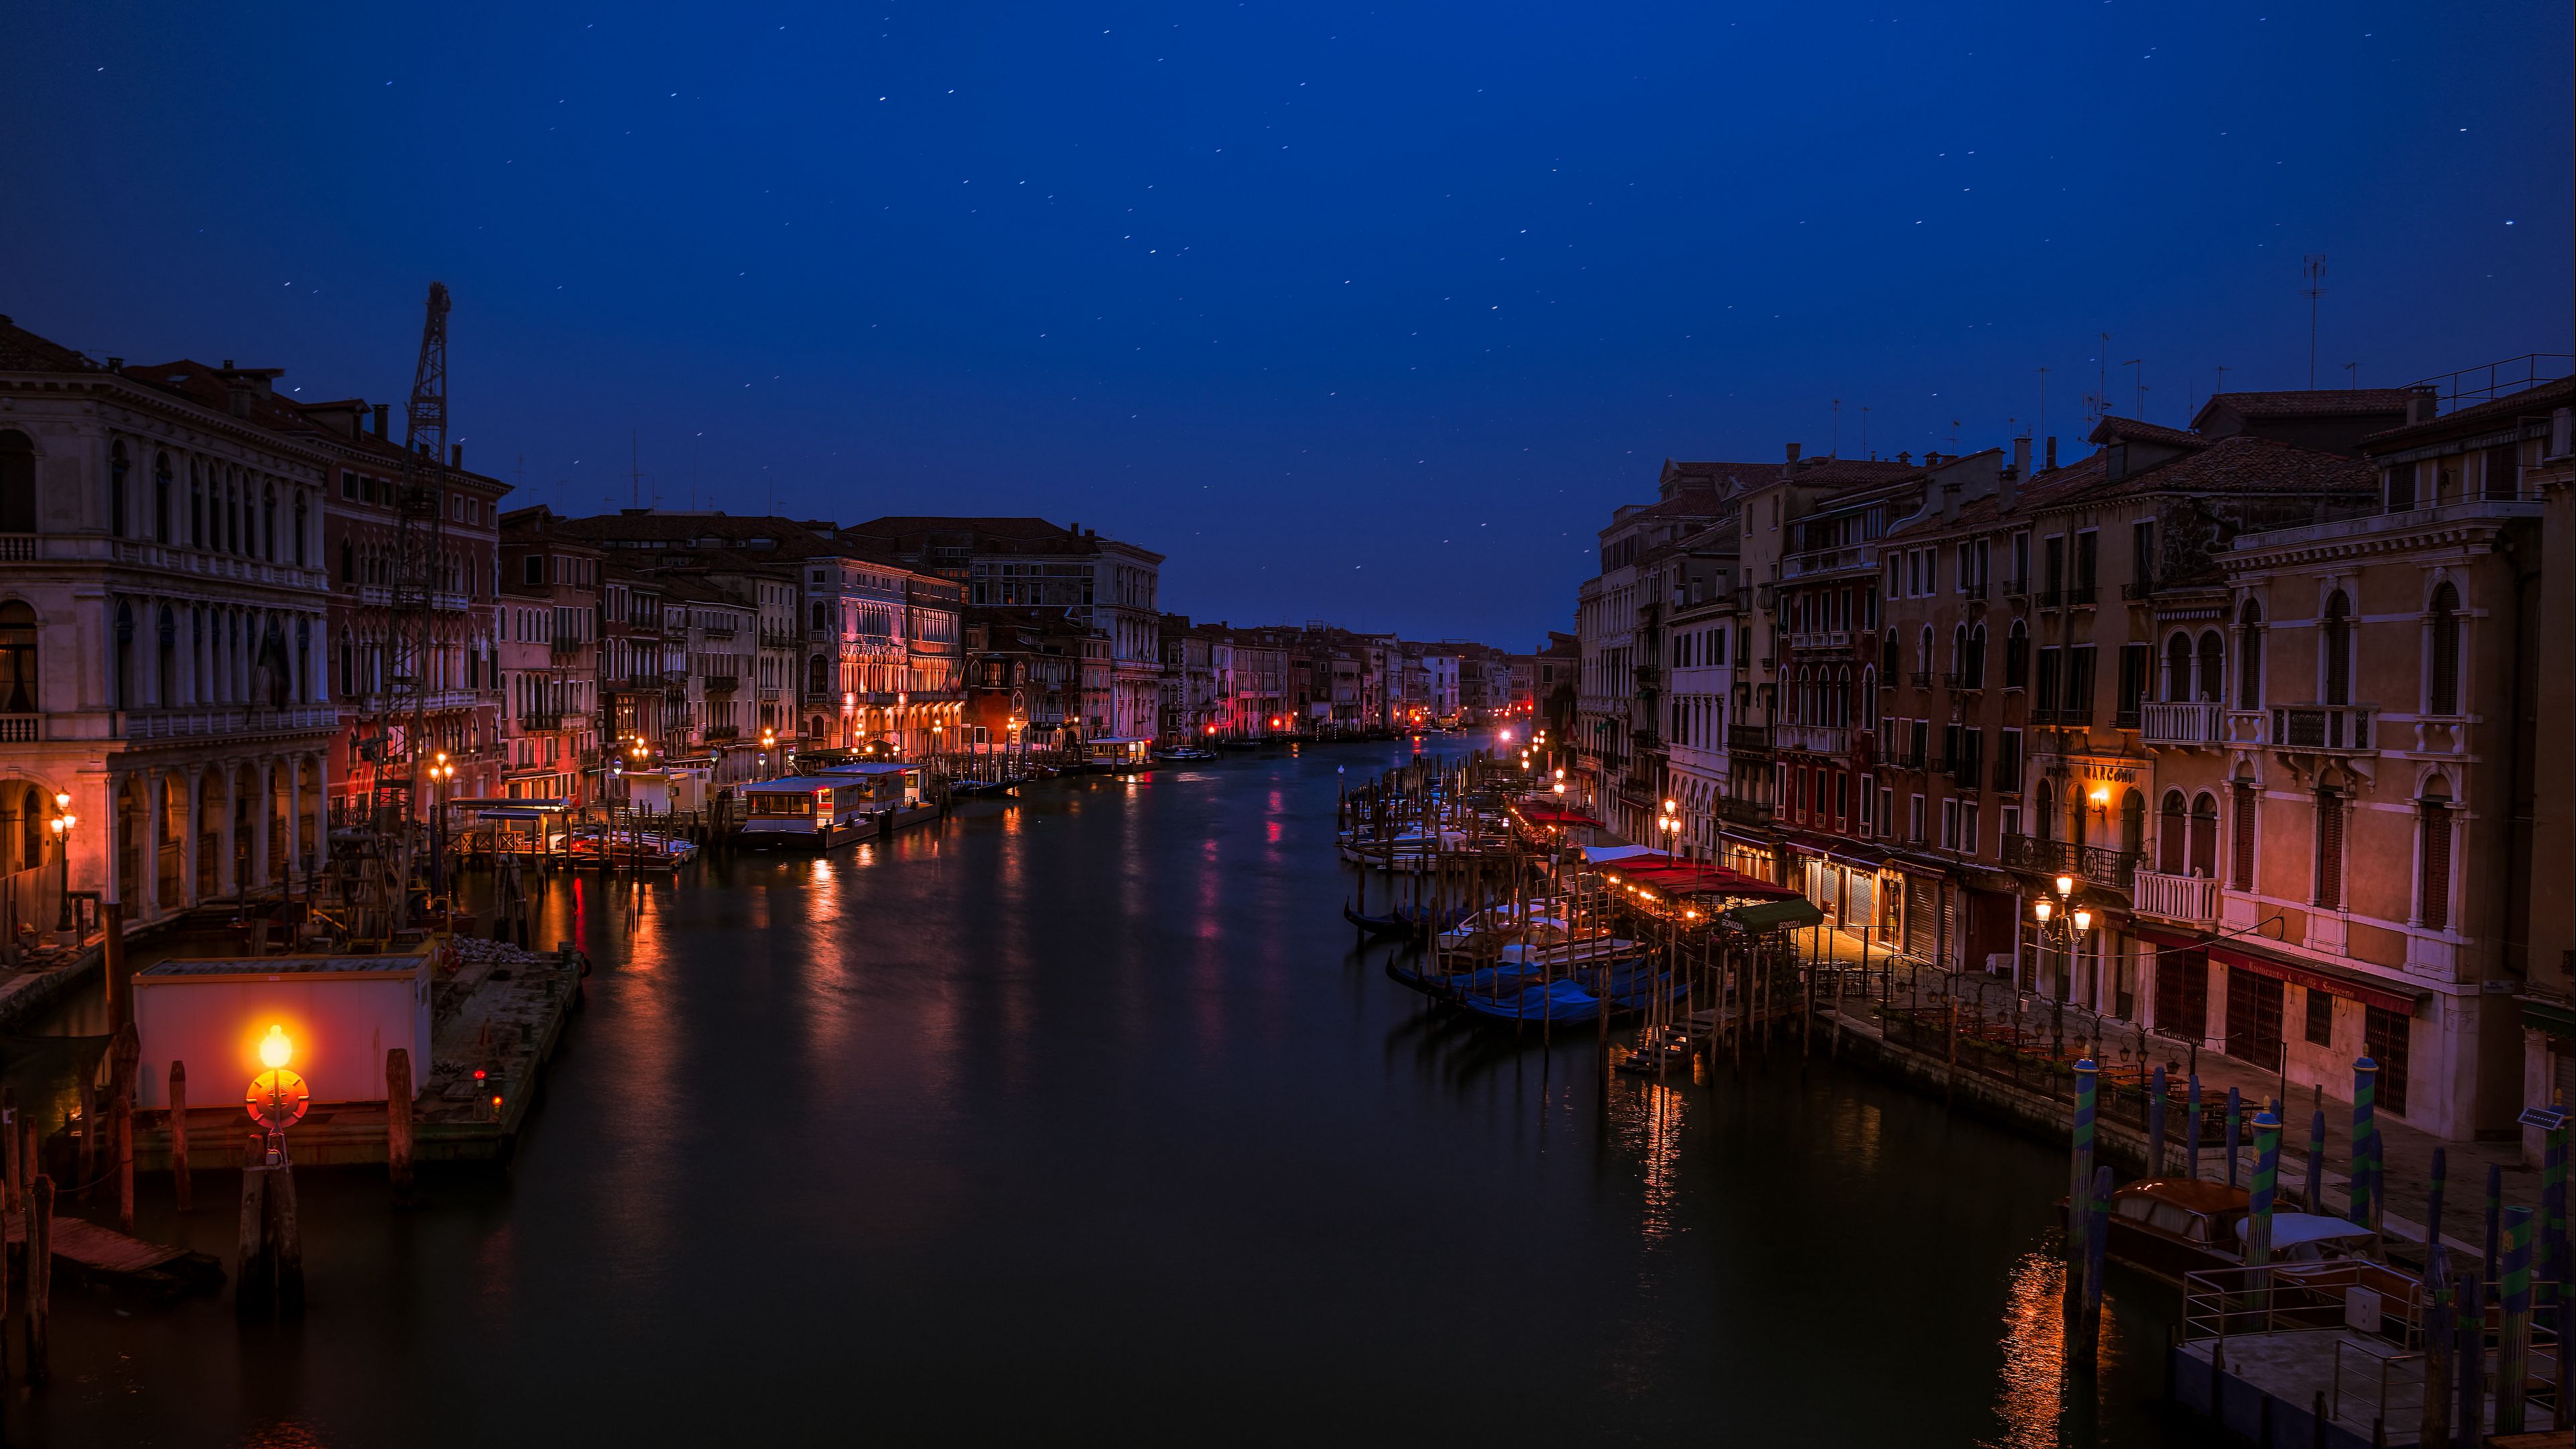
[134, 936, 585, 1173]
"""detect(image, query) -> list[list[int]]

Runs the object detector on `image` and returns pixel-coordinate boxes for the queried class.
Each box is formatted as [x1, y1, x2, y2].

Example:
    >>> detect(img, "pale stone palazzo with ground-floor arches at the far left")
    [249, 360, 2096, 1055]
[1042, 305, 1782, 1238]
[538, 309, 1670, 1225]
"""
[0, 317, 340, 928]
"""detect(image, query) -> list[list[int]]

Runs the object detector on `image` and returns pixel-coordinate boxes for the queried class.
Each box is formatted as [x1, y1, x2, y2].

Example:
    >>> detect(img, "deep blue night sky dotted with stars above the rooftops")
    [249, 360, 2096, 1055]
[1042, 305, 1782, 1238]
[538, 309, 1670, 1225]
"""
[0, 0, 2576, 647]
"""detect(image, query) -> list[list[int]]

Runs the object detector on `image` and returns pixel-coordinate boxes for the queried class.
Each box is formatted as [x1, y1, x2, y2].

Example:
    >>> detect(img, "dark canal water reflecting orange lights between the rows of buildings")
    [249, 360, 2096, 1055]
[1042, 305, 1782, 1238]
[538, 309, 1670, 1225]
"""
[30, 743, 2187, 1446]
